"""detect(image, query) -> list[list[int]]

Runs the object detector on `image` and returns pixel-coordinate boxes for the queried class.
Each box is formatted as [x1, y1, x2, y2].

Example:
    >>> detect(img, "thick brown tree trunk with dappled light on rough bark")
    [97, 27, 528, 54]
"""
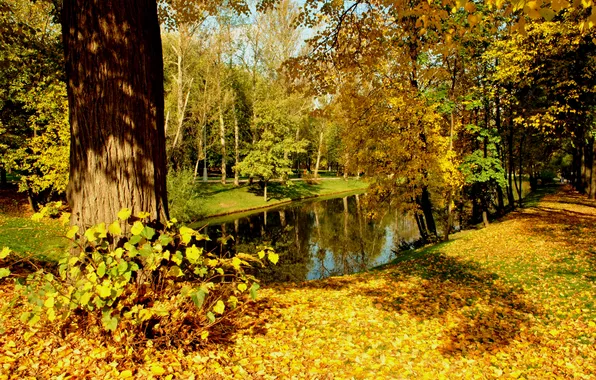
[62, 0, 168, 228]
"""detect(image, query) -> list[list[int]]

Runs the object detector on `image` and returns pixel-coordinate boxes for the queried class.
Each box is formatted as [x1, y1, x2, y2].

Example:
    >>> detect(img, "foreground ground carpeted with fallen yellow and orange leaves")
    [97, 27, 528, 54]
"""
[0, 186, 596, 379]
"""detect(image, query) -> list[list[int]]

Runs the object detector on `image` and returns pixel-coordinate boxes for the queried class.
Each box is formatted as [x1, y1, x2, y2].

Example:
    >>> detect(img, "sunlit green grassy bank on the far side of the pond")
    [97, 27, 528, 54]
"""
[171, 178, 368, 221]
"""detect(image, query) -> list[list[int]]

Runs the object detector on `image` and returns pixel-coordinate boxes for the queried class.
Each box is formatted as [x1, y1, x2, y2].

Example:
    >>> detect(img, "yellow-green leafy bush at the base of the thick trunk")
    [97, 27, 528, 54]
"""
[0, 209, 278, 345]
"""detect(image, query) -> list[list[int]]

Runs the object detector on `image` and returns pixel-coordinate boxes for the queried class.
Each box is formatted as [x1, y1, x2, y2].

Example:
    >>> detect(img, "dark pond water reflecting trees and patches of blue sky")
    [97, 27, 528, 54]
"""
[194, 194, 420, 282]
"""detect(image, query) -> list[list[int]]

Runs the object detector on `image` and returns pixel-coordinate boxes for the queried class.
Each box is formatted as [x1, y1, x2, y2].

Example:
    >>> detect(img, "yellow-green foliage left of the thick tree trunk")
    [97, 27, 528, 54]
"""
[0, 0, 70, 199]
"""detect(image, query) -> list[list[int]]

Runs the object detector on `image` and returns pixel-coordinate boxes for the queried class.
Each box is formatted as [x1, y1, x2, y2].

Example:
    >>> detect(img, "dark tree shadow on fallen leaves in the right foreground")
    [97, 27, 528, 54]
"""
[365, 252, 541, 356]
